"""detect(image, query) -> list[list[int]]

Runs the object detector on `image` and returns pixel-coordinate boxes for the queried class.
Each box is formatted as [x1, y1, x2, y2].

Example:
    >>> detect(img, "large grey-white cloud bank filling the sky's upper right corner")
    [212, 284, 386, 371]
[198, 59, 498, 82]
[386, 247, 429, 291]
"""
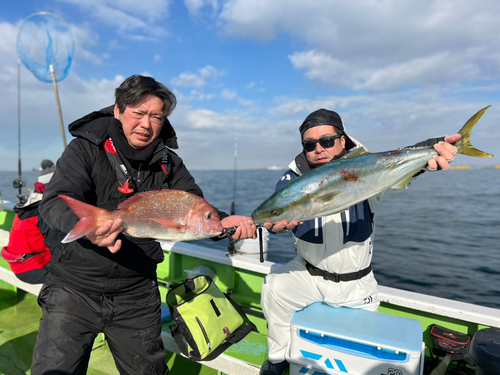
[219, 0, 500, 91]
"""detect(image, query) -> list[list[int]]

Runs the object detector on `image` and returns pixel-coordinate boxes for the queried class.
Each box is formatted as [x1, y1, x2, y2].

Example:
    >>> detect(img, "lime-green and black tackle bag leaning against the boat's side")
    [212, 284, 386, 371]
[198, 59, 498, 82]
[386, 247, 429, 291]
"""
[167, 275, 257, 361]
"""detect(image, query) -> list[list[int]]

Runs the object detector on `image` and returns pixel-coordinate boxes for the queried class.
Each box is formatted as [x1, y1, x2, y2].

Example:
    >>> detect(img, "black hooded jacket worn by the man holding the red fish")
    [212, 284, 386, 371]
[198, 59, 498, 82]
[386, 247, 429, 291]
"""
[39, 106, 227, 294]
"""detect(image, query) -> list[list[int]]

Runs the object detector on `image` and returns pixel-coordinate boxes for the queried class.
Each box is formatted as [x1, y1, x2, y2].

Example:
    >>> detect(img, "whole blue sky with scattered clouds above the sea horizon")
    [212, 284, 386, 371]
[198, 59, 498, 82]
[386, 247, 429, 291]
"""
[0, 0, 500, 170]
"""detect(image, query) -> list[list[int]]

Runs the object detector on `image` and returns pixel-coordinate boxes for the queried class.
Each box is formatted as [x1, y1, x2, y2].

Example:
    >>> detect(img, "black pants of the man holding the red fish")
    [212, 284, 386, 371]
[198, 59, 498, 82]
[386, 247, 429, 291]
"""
[31, 285, 168, 375]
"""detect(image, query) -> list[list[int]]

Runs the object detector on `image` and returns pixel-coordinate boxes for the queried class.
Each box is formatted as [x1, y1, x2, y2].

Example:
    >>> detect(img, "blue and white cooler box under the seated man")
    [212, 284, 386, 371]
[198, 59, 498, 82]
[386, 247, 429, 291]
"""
[286, 303, 425, 375]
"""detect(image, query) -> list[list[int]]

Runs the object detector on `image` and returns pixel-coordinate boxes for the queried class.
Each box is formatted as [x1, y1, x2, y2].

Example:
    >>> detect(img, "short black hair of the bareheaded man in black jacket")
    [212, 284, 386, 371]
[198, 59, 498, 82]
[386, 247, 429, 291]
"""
[115, 74, 177, 117]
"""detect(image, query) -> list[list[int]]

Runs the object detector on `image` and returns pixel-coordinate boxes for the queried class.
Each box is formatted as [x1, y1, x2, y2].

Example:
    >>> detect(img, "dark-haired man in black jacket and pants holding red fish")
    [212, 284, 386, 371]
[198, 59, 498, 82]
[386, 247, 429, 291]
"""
[31, 75, 256, 375]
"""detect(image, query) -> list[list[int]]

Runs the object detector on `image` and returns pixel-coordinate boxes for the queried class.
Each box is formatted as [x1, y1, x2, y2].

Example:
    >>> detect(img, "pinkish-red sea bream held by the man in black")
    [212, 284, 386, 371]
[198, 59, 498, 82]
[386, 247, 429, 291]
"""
[59, 190, 222, 243]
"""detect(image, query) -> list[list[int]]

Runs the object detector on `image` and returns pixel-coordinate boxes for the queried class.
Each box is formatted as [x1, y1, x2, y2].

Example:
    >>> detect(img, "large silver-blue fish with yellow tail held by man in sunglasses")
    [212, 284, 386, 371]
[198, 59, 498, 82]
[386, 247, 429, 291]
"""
[252, 106, 494, 223]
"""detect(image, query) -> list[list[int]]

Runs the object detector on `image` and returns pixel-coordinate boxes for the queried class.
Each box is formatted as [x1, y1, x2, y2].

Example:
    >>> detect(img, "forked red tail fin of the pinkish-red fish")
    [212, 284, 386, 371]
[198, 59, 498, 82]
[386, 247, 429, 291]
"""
[59, 195, 107, 243]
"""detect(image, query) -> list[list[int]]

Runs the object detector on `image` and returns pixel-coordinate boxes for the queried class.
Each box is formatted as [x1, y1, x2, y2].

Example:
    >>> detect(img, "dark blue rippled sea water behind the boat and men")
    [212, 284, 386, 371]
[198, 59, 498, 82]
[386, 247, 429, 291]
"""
[0, 167, 500, 308]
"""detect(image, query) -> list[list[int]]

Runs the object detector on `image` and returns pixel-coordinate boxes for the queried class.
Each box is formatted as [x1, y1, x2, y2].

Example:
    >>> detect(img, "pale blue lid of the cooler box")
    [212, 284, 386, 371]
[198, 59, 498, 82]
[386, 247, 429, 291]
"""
[292, 302, 423, 352]
